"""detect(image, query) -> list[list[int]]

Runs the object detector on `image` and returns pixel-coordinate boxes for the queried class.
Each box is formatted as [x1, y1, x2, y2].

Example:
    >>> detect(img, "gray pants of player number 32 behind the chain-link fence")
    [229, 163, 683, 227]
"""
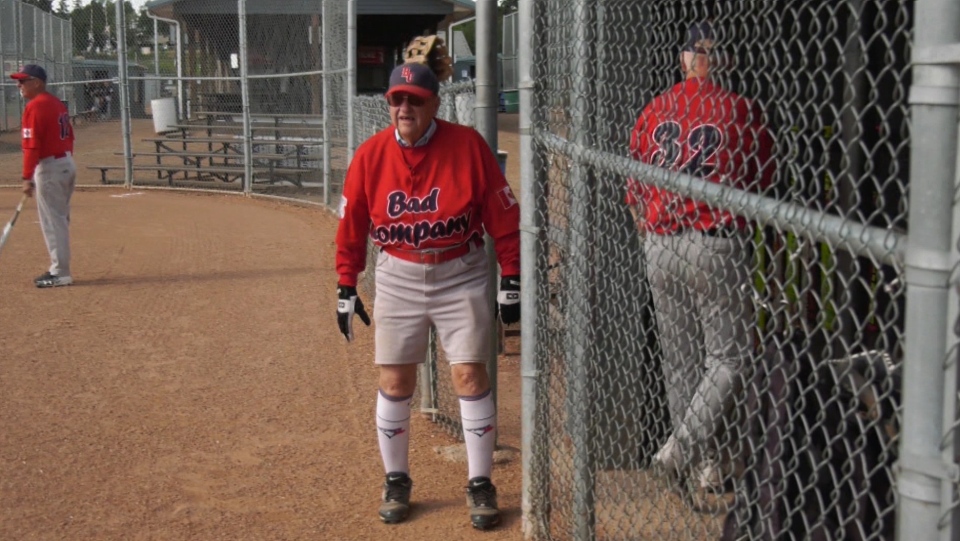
[645, 230, 753, 465]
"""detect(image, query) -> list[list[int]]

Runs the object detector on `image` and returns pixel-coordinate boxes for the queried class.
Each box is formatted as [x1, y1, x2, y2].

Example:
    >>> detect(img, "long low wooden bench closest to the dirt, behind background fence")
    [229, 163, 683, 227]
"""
[87, 164, 320, 187]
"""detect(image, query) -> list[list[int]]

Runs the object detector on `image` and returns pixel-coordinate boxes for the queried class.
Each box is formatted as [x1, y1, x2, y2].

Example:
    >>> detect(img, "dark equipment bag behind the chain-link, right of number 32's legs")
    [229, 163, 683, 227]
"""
[721, 335, 900, 541]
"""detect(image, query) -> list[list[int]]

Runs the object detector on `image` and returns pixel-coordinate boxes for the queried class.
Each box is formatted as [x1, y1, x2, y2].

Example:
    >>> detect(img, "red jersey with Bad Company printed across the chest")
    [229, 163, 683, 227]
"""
[337, 119, 520, 286]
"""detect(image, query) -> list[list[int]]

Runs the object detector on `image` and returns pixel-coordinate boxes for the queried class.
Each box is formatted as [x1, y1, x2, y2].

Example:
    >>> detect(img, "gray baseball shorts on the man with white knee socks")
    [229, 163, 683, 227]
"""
[373, 246, 494, 364]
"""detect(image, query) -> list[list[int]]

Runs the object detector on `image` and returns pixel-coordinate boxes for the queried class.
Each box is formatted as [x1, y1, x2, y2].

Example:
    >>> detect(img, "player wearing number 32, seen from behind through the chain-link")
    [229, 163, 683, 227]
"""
[627, 23, 772, 488]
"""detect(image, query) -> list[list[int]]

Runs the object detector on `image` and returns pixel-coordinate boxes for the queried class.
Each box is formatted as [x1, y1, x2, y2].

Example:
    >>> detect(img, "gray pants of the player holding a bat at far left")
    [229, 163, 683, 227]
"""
[33, 156, 77, 276]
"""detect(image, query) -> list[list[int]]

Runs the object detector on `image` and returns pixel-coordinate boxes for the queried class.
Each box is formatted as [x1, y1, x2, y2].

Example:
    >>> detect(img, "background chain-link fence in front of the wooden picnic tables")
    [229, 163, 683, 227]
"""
[84, 0, 351, 206]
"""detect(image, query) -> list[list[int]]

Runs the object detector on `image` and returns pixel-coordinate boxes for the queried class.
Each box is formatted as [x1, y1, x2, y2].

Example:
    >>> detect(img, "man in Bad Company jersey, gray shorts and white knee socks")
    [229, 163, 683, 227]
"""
[336, 60, 520, 529]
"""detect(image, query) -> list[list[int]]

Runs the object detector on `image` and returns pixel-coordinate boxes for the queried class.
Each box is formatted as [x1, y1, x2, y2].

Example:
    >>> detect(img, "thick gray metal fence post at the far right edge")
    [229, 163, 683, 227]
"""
[897, 0, 960, 541]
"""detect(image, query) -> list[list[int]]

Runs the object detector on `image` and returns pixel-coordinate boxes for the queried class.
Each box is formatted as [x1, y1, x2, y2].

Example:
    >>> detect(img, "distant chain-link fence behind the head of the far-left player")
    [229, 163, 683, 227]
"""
[0, 0, 74, 131]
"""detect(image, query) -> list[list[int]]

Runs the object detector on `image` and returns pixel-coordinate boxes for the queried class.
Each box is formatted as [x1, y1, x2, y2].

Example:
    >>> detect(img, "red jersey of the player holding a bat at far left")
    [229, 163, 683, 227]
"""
[21, 92, 73, 179]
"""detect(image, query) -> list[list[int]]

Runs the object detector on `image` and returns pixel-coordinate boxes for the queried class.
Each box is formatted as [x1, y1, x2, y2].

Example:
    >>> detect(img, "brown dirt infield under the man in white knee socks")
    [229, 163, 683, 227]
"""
[0, 113, 521, 540]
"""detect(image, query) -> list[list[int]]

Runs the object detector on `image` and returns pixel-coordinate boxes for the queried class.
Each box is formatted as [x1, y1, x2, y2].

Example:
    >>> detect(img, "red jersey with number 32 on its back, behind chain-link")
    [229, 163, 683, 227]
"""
[626, 79, 773, 234]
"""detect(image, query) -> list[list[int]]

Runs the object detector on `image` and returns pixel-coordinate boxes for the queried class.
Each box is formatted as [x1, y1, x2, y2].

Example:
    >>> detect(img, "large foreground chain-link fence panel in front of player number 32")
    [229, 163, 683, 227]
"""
[520, 0, 960, 540]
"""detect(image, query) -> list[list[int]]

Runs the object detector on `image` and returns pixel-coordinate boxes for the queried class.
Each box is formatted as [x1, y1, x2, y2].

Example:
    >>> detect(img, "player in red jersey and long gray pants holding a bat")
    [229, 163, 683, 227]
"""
[10, 64, 77, 287]
